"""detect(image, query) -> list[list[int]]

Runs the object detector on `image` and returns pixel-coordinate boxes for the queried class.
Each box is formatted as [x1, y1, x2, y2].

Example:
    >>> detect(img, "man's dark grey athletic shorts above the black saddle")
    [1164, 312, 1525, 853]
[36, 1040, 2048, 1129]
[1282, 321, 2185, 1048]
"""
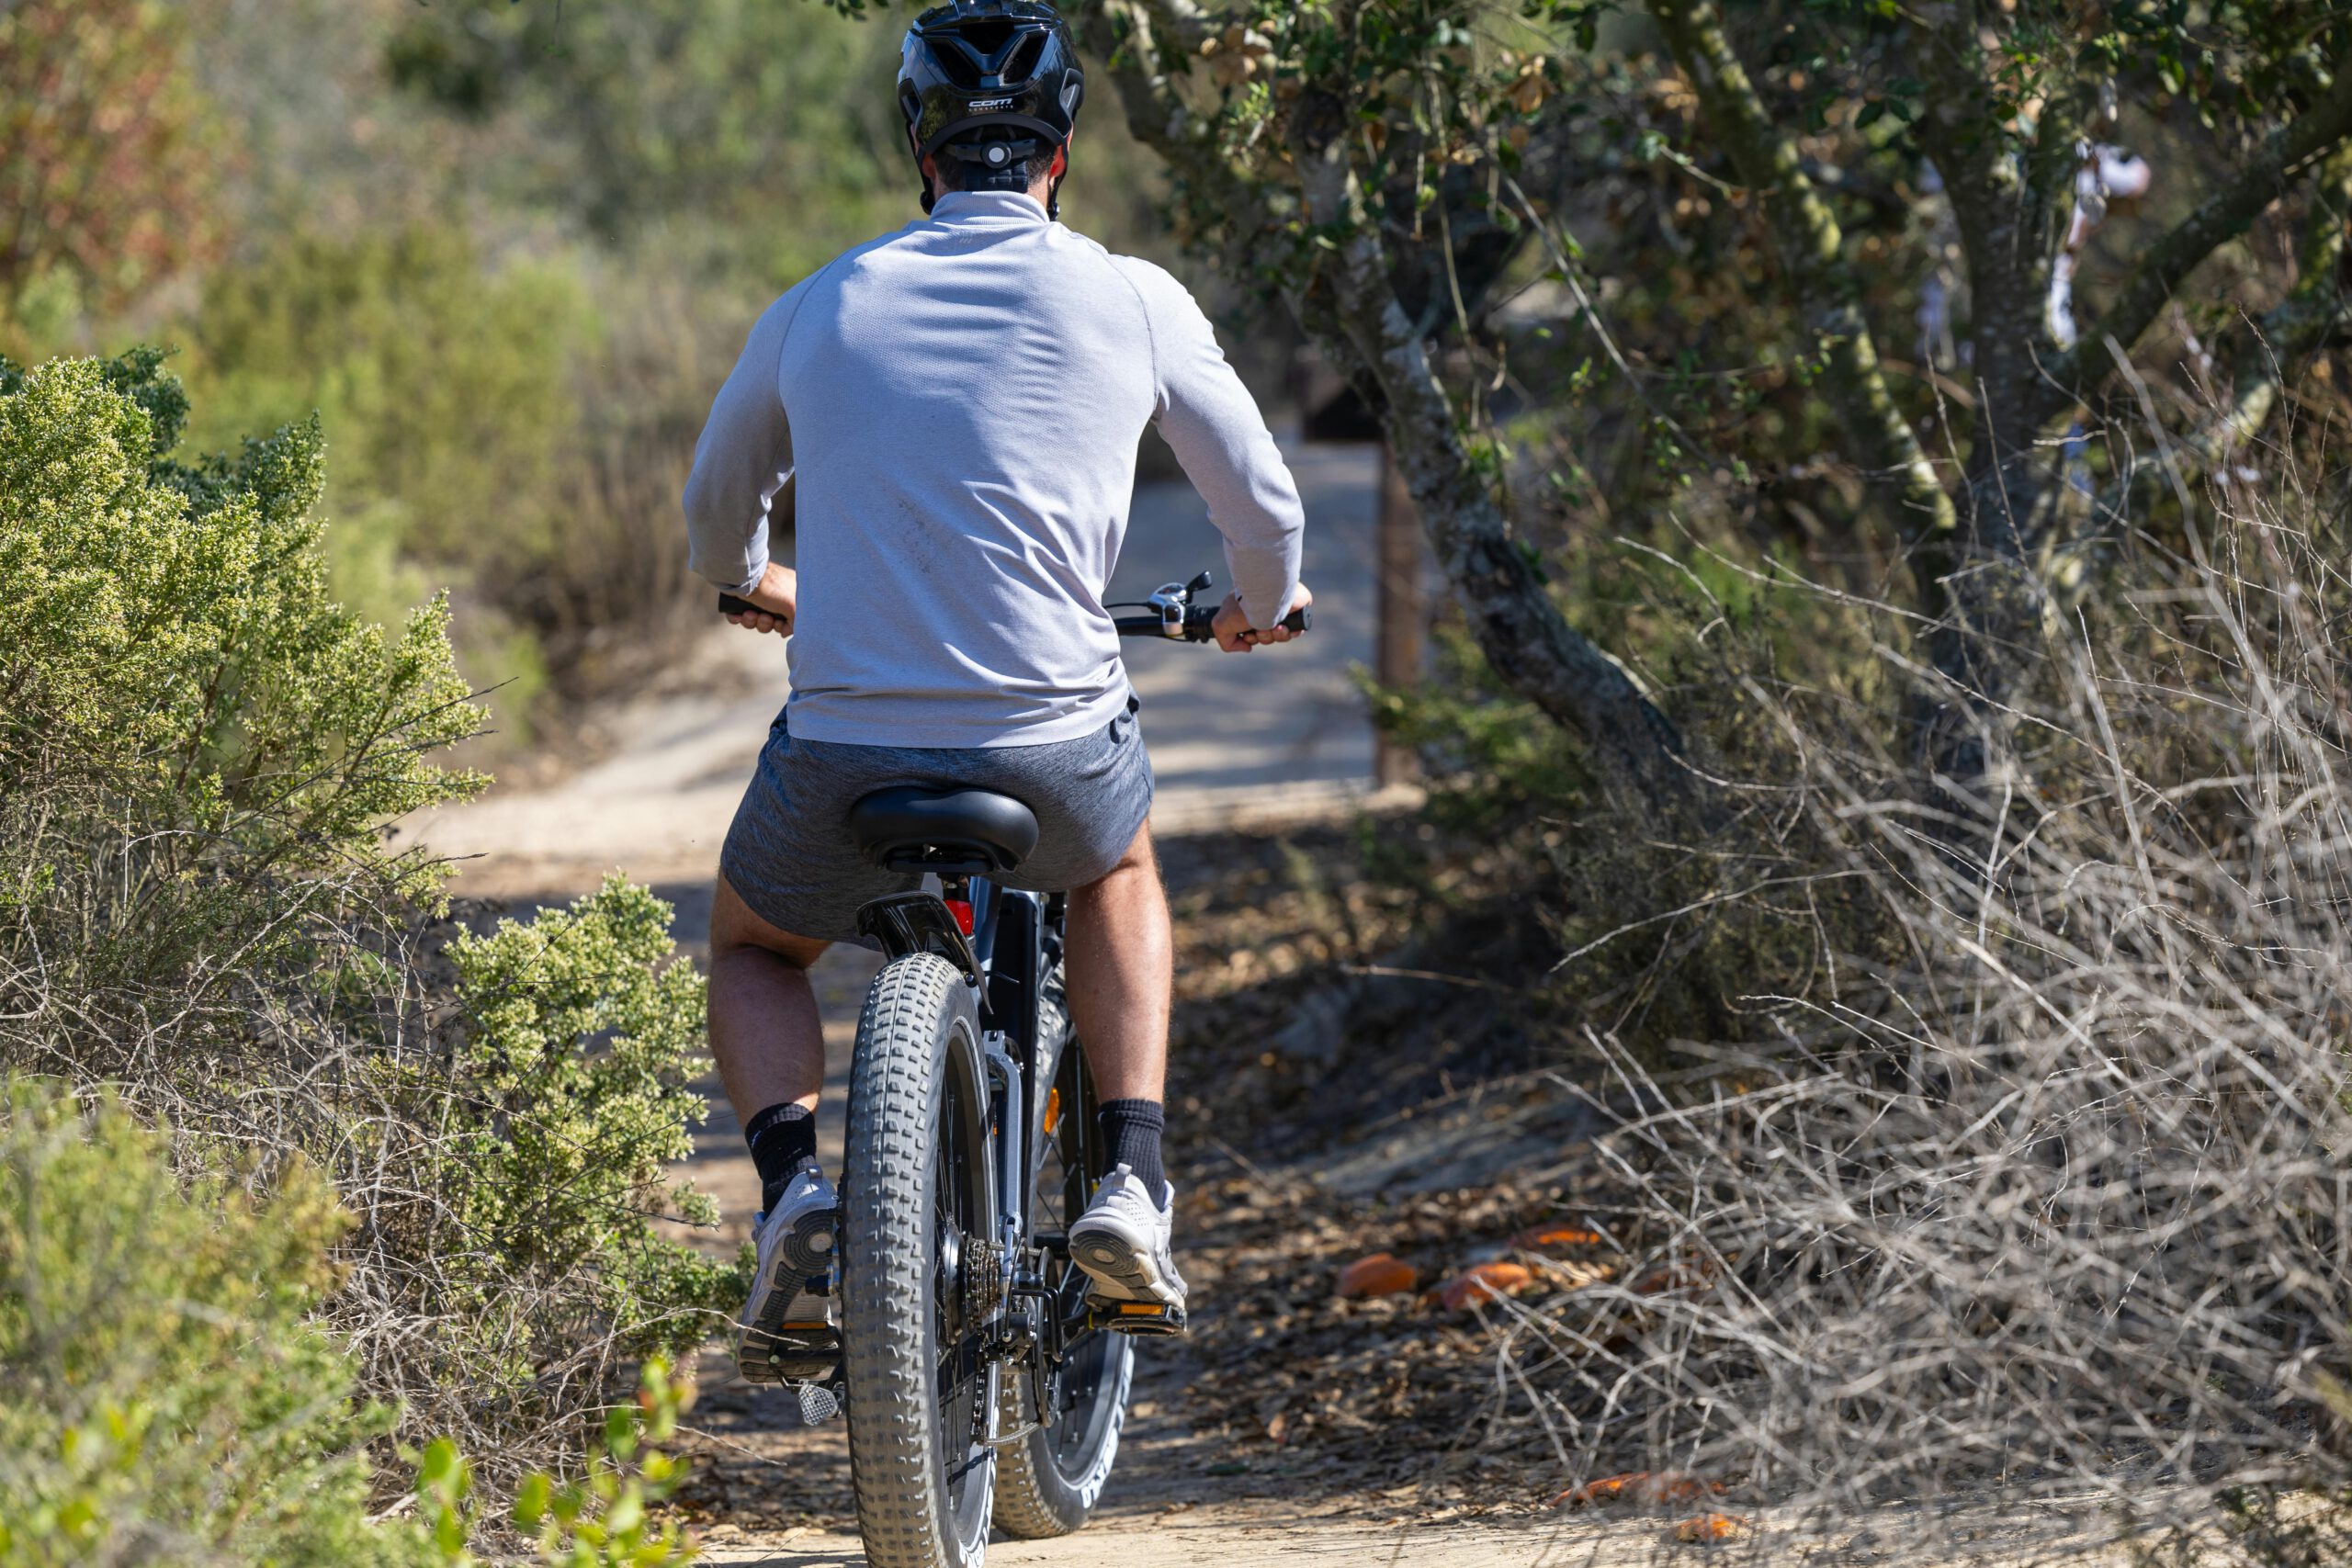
[719, 701, 1152, 942]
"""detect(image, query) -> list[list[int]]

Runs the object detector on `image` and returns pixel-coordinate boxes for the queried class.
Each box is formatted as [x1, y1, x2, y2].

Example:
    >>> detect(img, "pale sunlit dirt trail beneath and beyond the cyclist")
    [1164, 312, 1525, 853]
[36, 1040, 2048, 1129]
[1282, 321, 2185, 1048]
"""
[407, 449, 1543, 1568]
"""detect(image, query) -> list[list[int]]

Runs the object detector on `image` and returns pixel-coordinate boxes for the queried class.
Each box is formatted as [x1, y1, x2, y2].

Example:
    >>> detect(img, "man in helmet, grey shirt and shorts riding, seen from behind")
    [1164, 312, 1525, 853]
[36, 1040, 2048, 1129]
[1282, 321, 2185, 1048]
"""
[684, 0, 1310, 1382]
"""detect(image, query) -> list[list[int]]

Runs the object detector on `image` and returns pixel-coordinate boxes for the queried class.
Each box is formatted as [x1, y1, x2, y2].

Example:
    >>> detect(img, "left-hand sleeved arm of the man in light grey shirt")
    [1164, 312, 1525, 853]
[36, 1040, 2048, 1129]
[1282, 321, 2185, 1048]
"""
[684, 285, 807, 592]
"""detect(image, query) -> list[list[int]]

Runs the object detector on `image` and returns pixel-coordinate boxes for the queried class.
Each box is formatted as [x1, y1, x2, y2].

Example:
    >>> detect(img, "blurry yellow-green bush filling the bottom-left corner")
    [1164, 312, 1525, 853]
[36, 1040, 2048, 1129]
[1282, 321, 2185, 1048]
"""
[0, 1079, 428, 1568]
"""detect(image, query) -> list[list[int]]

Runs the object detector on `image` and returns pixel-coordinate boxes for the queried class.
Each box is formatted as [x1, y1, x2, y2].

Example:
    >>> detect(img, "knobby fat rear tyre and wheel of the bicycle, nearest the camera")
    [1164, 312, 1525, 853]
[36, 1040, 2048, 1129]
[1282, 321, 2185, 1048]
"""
[842, 952, 997, 1568]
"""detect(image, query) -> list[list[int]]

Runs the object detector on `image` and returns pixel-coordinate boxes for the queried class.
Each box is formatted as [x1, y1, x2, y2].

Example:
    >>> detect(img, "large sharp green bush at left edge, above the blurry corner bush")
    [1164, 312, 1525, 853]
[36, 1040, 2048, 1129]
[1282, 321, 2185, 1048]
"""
[0, 355, 480, 1024]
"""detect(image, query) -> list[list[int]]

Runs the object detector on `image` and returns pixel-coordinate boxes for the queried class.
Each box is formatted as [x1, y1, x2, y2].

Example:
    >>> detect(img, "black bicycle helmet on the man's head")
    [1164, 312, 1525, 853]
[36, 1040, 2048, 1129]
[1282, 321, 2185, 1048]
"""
[899, 0, 1087, 211]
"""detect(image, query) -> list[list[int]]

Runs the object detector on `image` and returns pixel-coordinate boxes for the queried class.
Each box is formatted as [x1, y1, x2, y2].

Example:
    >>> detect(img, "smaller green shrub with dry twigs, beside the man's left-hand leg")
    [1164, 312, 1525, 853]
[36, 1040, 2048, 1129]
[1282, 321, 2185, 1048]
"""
[336, 879, 743, 1481]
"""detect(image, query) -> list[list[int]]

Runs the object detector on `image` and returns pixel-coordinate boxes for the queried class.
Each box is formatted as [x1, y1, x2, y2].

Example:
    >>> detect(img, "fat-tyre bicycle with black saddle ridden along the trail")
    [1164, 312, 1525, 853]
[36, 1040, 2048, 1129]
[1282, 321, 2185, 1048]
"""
[719, 571, 1310, 1568]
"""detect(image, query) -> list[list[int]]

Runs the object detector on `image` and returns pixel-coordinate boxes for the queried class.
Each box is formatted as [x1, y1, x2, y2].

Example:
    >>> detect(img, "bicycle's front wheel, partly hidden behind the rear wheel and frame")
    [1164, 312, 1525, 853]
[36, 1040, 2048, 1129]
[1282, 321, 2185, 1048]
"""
[995, 971, 1136, 1540]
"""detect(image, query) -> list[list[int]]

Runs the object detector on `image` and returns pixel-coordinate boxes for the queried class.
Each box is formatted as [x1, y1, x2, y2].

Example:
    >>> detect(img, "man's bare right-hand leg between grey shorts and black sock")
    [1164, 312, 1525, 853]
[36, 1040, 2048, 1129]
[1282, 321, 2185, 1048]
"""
[1066, 823, 1173, 1102]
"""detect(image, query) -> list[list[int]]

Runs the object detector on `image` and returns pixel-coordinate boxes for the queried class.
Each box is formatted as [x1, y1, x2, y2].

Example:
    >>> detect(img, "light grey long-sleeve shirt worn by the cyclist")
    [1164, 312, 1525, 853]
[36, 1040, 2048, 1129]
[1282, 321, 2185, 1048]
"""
[684, 193, 1303, 748]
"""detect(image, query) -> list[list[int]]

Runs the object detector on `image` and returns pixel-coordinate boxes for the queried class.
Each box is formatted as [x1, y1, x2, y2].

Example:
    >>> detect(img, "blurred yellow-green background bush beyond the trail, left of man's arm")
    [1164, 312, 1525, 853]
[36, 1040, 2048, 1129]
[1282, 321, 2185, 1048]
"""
[188, 226, 736, 733]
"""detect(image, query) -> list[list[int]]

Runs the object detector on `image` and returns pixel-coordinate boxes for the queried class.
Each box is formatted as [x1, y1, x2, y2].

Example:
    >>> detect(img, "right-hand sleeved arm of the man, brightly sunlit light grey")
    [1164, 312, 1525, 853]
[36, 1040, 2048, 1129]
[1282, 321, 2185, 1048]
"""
[1114, 256, 1306, 632]
